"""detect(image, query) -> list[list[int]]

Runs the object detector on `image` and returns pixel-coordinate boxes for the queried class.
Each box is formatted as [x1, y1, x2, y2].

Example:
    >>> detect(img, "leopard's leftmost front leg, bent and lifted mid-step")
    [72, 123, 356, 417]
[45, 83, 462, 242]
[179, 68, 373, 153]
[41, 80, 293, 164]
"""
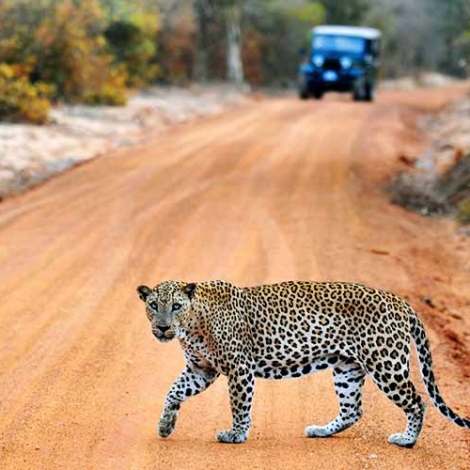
[158, 366, 219, 437]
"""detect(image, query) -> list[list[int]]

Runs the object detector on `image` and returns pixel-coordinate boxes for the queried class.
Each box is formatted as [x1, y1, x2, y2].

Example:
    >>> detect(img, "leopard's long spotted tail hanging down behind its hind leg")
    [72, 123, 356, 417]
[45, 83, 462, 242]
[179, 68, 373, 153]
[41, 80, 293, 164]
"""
[410, 308, 470, 429]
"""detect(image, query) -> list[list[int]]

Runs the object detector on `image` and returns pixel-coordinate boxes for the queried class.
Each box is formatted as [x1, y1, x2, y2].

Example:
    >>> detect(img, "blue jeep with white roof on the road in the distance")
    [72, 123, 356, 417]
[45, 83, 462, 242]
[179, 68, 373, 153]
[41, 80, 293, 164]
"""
[299, 26, 380, 101]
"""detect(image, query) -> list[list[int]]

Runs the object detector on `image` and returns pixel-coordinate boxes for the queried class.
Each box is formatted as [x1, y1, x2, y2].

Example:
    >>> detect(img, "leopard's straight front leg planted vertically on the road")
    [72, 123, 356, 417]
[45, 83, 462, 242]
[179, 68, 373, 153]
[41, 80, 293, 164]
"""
[217, 364, 255, 444]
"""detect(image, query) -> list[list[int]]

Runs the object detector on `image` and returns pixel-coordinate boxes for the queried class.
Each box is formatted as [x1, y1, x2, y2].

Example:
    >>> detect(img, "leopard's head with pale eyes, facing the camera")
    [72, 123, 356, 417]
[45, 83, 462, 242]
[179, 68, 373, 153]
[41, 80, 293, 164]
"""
[137, 281, 196, 343]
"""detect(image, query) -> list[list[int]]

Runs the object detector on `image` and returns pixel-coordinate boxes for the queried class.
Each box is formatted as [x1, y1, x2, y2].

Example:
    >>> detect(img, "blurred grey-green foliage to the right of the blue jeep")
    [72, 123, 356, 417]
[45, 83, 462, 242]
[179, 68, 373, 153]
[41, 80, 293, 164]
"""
[364, 0, 470, 77]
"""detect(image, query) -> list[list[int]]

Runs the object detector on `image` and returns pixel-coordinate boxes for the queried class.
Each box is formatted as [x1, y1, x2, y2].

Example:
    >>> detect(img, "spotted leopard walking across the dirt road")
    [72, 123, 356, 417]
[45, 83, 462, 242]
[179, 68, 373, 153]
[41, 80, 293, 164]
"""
[137, 280, 470, 448]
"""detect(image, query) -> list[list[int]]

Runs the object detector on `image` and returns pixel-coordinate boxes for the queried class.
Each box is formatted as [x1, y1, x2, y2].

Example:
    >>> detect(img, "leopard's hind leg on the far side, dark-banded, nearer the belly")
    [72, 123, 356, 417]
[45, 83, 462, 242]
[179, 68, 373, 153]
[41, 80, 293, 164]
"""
[305, 360, 366, 437]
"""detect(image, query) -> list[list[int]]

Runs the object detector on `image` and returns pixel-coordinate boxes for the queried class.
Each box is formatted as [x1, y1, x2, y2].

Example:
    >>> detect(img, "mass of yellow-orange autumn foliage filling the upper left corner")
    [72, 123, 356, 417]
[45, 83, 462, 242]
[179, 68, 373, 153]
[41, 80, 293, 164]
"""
[0, 0, 158, 123]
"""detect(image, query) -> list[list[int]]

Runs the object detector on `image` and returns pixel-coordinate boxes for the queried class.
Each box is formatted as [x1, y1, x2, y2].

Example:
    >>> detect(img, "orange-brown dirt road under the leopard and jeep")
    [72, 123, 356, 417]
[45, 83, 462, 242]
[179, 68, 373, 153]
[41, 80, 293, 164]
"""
[0, 89, 470, 470]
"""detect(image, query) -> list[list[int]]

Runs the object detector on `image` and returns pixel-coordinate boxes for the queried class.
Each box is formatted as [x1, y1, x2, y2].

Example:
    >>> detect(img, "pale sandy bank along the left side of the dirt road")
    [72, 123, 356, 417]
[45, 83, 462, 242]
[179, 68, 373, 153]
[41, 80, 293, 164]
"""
[0, 84, 249, 199]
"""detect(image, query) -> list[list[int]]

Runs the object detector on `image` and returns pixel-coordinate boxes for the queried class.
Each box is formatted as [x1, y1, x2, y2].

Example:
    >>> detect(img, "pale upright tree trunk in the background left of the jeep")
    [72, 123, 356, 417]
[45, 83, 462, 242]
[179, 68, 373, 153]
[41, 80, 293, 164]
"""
[225, 1, 245, 86]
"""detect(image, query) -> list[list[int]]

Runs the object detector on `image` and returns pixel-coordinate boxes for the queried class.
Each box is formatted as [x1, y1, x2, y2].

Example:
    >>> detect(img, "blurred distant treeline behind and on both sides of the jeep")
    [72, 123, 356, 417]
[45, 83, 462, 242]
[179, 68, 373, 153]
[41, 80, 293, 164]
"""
[166, 0, 470, 85]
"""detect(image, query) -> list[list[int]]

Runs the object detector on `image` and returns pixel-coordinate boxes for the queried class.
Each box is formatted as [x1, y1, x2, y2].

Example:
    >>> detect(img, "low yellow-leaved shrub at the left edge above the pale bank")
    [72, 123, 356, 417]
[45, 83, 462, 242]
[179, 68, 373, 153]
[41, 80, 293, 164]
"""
[0, 63, 54, 124]
